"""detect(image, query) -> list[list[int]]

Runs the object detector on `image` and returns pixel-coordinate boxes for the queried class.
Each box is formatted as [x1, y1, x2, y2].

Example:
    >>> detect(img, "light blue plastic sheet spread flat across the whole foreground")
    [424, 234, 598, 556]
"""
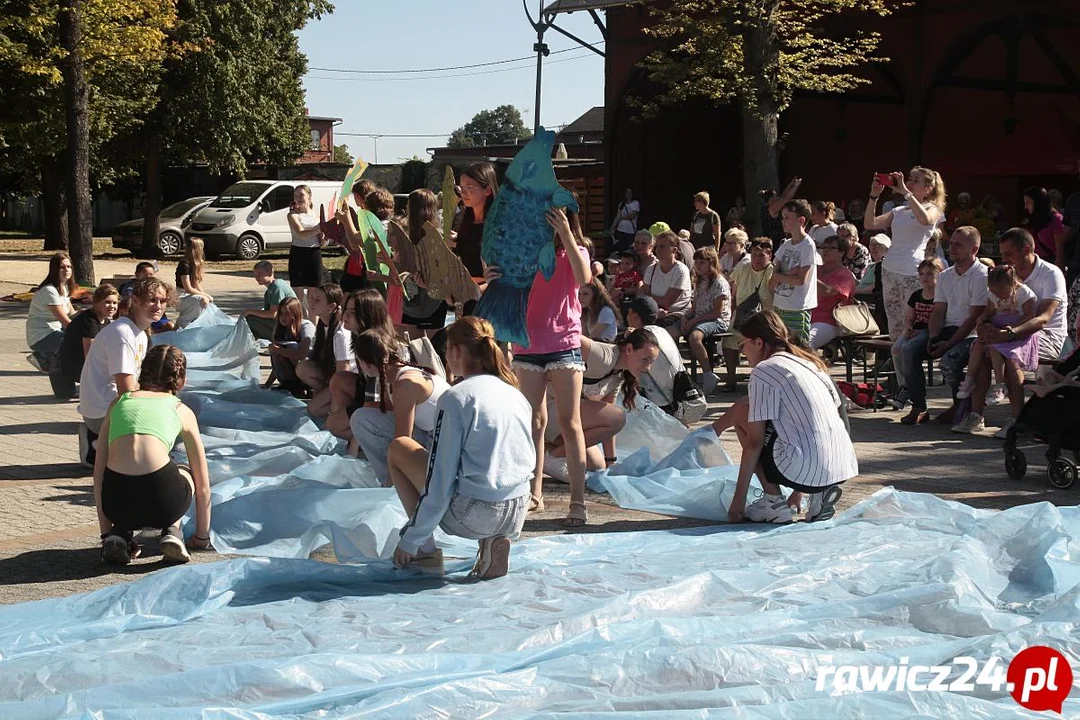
[0, 489, 1080, 720]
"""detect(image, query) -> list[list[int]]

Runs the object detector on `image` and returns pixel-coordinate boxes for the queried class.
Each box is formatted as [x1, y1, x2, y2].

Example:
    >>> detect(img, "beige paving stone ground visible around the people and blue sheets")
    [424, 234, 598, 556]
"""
[0, 259, 1067, 603]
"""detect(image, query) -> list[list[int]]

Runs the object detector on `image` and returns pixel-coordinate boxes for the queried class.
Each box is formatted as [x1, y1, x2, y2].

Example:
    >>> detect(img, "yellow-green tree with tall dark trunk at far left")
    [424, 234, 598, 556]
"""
[0, 0, 176, 283]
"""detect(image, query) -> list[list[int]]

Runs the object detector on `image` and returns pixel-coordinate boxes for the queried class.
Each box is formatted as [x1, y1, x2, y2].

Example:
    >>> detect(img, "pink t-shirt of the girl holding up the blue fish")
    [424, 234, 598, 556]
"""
[513, 244, 591, 355]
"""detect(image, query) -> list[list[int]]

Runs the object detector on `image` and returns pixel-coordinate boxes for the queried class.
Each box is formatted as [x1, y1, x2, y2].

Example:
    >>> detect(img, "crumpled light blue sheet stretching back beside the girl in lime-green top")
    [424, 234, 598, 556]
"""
[156, 313, 476, 561]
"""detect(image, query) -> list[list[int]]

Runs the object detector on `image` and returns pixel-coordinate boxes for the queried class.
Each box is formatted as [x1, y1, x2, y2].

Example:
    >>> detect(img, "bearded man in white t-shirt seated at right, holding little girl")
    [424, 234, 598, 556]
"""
[963, 228, 1068, 438]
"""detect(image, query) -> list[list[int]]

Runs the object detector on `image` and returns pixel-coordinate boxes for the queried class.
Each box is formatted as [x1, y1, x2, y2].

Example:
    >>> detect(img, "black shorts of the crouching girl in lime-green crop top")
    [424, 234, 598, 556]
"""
[102, 460, 192, 534]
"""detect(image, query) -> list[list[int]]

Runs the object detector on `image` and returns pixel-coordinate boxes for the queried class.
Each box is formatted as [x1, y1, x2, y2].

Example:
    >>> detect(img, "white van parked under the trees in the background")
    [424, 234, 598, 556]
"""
[184, 180, 341, 260]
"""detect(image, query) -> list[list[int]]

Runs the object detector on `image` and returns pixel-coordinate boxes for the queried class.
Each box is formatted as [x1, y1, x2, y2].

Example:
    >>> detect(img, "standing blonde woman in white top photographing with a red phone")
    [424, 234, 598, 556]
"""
[865, 166, 945, 341]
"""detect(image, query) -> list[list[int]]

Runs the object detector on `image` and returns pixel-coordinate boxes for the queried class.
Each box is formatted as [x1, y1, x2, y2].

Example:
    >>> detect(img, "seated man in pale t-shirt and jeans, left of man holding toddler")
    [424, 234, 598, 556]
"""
[901, 226, 988, 425]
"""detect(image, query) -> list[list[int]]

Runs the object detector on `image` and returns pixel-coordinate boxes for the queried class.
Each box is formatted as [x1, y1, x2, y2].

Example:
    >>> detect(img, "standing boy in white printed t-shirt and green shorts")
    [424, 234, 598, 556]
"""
[769, 200, 820, 345]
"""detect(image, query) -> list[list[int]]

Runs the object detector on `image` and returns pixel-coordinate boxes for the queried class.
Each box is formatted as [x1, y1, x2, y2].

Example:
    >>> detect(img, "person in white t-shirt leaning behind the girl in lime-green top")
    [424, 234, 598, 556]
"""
[79, 276, 168, 467]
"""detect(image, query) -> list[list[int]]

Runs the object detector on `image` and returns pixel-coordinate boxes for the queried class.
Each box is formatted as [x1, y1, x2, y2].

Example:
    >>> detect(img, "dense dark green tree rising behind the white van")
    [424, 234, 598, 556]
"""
[143, 0, 334, 254]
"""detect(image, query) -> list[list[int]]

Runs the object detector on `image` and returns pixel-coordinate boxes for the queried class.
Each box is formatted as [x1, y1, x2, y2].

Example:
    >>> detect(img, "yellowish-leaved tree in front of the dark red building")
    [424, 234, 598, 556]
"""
[639, 0, 889, 231]
